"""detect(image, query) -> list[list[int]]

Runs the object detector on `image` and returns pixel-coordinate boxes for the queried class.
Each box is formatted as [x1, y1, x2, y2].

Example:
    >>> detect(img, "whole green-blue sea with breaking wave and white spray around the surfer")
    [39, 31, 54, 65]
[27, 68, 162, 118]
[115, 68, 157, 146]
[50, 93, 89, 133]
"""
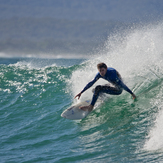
[0, 23, 163, 163]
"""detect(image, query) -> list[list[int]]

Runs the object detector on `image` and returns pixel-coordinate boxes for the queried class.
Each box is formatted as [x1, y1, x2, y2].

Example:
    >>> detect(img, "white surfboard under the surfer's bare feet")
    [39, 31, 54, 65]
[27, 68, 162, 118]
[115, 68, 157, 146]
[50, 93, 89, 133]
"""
[61, 101, 91, 120]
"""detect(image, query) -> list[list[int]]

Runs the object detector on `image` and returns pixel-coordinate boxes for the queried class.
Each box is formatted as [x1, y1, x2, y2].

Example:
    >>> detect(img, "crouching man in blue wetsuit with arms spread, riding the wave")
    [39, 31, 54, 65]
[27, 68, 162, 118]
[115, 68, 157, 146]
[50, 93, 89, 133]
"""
[75, 63, 136, 111]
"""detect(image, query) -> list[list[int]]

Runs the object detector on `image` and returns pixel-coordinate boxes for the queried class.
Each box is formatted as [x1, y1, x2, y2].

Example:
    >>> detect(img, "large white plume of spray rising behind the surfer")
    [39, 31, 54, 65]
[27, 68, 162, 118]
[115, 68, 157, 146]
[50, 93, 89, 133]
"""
[70, 23, 163, 102]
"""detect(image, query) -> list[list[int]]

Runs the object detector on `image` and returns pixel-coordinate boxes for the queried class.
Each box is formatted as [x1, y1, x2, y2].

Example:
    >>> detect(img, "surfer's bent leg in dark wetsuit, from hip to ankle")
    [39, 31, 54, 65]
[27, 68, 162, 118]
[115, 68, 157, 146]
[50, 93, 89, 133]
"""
[91, 85, 123, 106]
